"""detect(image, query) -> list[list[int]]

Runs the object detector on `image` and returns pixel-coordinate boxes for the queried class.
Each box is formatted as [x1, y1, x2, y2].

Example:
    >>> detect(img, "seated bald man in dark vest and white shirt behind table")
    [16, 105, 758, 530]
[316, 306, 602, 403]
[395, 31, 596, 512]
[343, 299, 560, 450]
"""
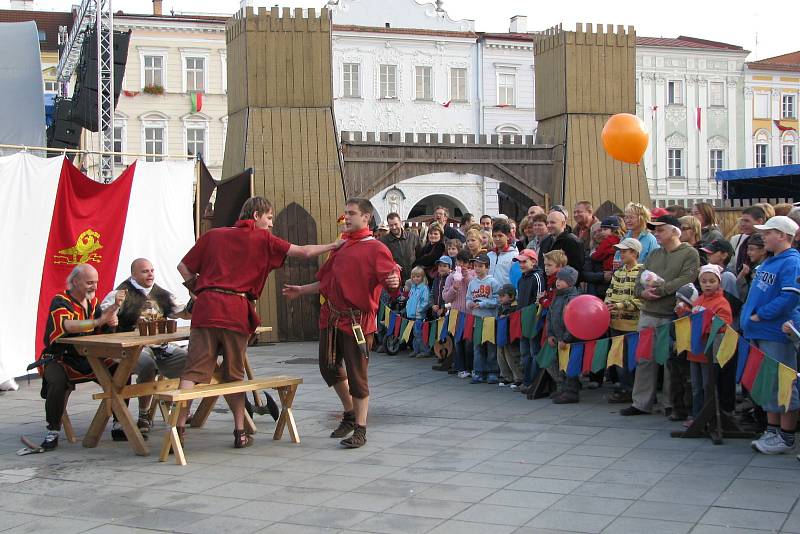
[100, 258, 191, 439]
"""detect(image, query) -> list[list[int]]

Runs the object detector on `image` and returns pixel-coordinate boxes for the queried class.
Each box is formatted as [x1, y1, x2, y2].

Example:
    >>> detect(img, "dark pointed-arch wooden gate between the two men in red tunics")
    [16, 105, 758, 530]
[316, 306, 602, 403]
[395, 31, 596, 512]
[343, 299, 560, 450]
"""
[273, 202, 319, 341]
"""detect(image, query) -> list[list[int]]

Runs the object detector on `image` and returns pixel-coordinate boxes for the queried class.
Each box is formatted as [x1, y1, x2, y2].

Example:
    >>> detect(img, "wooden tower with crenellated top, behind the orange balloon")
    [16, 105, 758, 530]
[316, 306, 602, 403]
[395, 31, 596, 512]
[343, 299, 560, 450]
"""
[534, 24, 650, 215]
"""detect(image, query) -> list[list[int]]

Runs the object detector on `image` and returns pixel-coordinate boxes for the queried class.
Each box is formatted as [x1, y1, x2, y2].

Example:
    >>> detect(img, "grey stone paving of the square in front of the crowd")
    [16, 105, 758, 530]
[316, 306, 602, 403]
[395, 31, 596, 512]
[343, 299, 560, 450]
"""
[0, 343, 800, 534]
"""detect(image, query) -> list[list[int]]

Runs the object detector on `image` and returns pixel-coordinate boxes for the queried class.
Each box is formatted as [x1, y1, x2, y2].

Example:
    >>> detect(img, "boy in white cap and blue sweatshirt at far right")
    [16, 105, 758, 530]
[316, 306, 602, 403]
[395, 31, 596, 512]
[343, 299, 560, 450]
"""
[740, 216, 800, 454]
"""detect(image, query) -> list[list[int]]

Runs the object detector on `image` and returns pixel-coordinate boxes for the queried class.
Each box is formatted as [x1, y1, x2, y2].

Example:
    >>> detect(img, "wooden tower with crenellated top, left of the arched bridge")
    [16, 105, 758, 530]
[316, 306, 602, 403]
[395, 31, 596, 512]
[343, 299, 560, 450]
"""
[223, 7, 344, 341]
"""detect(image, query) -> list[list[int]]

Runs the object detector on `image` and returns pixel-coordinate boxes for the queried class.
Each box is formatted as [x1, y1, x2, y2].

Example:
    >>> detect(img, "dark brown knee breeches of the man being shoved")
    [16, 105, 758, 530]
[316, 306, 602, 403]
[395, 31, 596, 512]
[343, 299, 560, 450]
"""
[319, 328, 373, 399]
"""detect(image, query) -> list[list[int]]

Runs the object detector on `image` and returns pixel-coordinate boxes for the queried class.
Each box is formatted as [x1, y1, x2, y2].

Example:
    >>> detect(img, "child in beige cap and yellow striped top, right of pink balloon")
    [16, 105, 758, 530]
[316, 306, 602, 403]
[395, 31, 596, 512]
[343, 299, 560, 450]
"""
[604, 237, 642, 404]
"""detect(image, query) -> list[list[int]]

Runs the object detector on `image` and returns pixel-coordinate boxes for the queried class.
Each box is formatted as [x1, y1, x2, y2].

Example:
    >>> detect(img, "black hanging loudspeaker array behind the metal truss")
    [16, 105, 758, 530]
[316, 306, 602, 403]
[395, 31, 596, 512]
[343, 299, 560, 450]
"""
[71, 31, 131, 132]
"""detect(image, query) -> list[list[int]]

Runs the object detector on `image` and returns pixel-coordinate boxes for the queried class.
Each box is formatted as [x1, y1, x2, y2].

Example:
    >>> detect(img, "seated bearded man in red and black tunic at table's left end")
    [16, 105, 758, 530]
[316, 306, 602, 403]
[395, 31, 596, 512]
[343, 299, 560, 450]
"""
[29, 263, 124, 451]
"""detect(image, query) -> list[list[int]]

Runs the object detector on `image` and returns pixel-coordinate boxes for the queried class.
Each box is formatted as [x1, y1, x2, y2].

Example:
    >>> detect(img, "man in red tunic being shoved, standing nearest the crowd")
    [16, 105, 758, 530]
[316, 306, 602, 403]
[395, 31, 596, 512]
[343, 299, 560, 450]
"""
[283, 198, 400, 449]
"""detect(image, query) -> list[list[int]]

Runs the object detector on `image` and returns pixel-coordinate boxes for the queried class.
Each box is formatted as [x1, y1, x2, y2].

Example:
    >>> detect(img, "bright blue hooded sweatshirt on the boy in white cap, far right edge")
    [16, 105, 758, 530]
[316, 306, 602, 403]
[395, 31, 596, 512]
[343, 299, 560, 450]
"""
[741, 248, 800, 343]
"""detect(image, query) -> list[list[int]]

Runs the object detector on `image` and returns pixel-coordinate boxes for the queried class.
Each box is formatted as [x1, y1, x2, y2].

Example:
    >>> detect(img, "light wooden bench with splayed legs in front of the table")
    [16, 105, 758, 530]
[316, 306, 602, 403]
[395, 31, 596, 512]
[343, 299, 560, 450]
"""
[154, 376, 303, 465]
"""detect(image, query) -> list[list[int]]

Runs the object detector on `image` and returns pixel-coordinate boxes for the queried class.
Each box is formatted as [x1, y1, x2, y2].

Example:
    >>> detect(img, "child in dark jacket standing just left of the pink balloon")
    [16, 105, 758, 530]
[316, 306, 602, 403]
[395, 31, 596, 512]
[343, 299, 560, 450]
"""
[545, 268, 580, 404]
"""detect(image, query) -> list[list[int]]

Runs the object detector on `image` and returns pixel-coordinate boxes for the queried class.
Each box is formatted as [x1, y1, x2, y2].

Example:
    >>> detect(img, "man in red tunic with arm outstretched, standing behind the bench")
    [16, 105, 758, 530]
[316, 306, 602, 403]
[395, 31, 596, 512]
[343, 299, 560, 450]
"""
[178, 197, 342, 448]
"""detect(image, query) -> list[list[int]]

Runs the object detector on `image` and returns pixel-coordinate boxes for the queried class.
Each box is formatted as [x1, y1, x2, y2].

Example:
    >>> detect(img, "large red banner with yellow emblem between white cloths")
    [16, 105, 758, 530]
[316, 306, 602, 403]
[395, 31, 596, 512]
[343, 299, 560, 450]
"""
[36, 159, 136, 358]
